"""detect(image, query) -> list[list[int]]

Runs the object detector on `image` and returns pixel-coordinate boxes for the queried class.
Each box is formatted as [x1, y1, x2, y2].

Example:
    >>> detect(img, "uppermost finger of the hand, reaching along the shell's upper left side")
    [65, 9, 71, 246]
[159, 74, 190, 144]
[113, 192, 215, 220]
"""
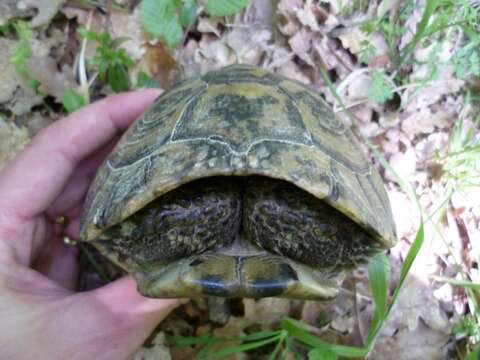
[0, 90, 158, 219]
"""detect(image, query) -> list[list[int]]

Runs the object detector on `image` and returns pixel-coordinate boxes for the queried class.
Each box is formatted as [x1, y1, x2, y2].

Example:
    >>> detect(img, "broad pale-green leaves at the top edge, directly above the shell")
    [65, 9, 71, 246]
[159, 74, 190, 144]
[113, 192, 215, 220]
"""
[140, 0, 250, 48]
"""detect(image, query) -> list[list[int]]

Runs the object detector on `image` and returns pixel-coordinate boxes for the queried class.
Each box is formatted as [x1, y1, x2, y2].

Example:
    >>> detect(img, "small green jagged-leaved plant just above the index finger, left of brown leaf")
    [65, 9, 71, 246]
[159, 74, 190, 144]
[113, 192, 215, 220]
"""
[77, 28, 135, 92]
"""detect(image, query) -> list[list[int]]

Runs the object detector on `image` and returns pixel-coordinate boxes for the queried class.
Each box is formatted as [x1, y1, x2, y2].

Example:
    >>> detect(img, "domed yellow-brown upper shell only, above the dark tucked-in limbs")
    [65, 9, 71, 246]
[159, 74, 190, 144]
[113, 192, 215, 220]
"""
[81, 65, 396, 248]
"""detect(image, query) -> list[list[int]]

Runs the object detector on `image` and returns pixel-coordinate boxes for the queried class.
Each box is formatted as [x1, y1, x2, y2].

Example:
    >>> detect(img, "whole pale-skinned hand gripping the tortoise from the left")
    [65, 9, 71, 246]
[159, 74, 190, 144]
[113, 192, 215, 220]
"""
[0, 90, 179, 360]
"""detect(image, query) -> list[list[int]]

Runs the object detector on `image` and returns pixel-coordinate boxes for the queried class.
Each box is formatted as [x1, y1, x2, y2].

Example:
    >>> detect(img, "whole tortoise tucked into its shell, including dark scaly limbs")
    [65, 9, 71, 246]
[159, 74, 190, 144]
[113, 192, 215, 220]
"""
[81, 65, 396, 300]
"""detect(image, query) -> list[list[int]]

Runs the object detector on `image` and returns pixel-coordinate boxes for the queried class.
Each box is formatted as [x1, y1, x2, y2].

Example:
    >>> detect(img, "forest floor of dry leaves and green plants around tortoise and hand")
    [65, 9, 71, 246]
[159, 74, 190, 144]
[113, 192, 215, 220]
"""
[0, 0, 480, 360]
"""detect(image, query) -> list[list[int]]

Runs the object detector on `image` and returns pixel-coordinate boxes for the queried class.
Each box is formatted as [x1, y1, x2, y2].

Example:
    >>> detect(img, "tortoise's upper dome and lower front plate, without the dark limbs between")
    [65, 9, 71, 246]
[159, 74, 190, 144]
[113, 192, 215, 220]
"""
[81, 65, 396, 299]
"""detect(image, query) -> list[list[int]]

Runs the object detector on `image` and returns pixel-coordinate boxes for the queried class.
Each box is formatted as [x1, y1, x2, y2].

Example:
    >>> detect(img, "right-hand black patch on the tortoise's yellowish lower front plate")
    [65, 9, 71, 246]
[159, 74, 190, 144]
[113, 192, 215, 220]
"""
[248, 263, 298, 298]
